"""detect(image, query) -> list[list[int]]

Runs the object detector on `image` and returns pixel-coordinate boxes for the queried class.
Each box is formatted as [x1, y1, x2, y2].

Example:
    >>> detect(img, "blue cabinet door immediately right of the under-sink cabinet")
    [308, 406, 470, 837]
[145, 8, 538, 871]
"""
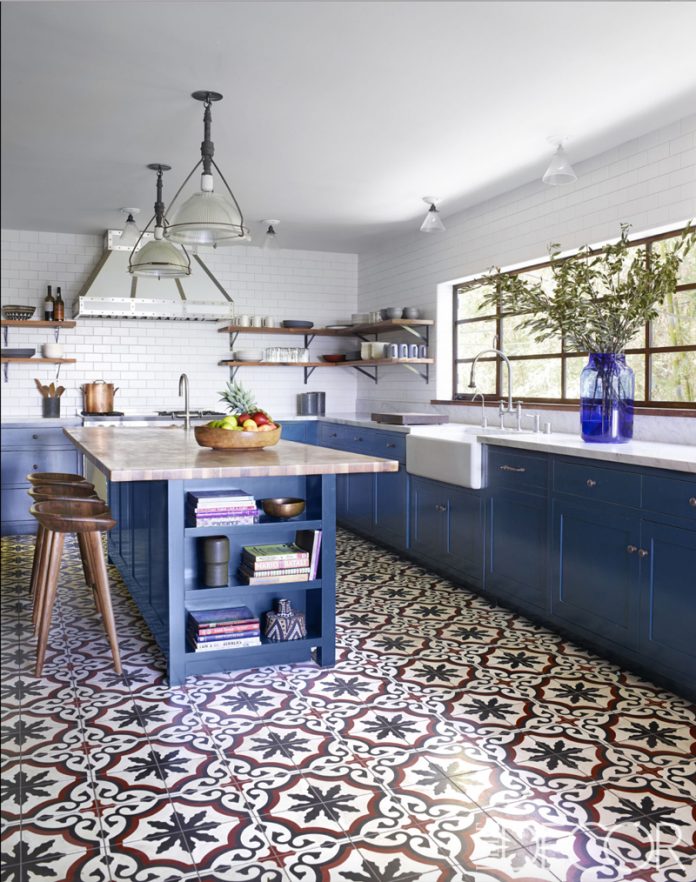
[485, 490, 548, 612]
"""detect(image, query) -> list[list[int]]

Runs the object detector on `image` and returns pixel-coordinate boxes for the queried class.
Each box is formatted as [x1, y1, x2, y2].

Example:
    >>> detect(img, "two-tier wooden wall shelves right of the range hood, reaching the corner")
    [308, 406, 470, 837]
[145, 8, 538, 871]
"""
[218, 319, 435, 384]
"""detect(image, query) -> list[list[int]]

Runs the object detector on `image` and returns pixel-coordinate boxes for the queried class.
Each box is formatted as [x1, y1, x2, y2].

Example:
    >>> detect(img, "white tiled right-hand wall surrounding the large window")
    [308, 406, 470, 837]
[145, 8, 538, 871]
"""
[358, 115, 696, 443]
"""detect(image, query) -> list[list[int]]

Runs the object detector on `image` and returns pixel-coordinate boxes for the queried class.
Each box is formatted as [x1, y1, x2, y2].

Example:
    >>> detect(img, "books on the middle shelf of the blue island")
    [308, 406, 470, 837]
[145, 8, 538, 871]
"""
[239, 530, 321, 585]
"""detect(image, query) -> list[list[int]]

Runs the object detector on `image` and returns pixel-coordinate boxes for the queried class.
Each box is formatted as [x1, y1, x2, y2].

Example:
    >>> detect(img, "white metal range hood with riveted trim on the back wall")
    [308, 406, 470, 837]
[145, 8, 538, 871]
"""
[73, 230, 234, 322]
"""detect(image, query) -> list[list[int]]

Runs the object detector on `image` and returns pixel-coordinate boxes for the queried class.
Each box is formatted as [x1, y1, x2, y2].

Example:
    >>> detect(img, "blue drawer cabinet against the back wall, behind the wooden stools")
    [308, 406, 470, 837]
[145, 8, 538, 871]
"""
[0, 422, 82, 536]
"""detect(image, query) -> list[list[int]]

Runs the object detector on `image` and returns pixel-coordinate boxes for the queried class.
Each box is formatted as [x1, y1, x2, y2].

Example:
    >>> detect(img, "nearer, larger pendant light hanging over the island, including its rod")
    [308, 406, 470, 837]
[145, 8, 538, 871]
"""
[165, 91, 251, 247]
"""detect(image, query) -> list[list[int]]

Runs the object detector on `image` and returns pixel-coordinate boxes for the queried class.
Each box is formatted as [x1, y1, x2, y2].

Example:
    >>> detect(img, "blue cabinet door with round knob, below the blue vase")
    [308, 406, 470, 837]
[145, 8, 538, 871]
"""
[552, 497, 640, 648]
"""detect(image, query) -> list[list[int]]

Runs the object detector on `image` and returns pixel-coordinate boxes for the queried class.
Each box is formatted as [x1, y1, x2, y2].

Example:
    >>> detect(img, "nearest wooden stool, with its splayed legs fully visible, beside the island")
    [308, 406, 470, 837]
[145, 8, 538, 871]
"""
[31, 499, 121, 676]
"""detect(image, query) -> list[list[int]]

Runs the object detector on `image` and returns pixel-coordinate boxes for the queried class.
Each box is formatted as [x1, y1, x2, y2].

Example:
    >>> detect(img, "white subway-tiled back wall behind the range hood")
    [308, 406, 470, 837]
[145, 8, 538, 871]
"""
[2, 230, 357, 418]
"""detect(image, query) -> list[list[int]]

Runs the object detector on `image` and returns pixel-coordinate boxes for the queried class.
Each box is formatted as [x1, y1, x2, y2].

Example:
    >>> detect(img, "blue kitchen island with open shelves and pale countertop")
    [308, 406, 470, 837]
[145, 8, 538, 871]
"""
[65, 427, 399, 685]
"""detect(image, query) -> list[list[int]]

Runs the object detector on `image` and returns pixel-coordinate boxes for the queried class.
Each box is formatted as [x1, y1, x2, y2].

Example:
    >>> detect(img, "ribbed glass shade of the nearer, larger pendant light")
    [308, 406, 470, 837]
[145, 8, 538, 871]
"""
[165, 191, 251, 245]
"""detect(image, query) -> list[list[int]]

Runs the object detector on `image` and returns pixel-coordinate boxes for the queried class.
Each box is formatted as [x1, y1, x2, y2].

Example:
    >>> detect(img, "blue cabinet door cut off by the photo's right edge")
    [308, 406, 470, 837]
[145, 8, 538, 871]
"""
[639, 518, 696, 672]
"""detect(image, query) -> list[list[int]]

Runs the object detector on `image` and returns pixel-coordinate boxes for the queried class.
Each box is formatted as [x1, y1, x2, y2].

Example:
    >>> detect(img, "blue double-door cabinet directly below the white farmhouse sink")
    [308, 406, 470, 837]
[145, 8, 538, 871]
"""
[410, 476, 483, 587]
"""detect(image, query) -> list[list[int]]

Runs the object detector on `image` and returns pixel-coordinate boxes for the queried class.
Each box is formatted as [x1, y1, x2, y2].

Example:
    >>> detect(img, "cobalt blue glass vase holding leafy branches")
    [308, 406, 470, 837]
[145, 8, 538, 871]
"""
[580, 352, 635, 444]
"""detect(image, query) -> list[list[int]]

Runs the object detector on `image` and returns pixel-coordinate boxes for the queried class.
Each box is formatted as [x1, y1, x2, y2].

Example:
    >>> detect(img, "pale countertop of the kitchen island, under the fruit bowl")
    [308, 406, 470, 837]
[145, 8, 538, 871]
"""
[64, 426, 399, 481]
